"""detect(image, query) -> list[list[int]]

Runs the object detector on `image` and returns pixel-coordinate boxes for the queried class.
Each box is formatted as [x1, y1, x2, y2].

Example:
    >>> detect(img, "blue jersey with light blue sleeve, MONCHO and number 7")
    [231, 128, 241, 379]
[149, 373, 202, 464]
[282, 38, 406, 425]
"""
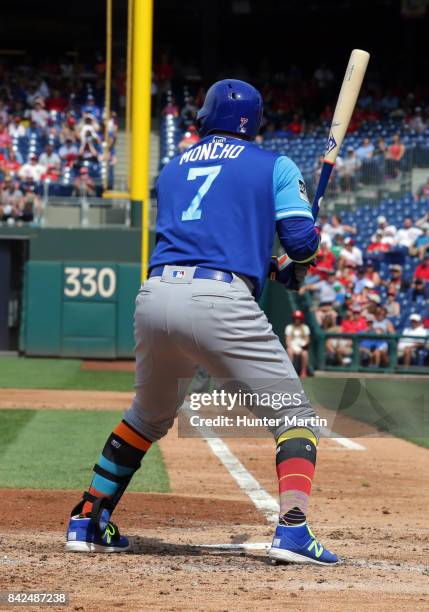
[150, 135, 313, 297]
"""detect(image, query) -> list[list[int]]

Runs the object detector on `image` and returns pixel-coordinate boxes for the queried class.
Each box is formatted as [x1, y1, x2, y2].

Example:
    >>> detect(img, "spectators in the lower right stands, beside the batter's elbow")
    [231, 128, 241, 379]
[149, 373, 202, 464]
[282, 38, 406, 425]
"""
[300, 206, 429, 367]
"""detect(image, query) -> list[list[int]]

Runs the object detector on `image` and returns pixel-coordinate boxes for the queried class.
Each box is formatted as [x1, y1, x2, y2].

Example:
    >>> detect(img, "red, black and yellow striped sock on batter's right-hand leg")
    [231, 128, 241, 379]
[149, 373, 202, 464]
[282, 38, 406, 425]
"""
[276, 427, 317, 525]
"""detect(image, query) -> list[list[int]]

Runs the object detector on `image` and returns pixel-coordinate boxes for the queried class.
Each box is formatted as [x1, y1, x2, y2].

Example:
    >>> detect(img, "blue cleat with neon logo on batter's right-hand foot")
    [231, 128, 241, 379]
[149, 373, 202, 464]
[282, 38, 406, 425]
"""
[268, 523, 338, 565]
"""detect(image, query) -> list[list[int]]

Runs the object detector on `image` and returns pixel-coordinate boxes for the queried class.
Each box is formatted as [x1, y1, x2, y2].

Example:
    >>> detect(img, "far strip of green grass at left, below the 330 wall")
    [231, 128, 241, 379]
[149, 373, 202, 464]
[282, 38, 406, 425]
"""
[0, 357, 134, 391]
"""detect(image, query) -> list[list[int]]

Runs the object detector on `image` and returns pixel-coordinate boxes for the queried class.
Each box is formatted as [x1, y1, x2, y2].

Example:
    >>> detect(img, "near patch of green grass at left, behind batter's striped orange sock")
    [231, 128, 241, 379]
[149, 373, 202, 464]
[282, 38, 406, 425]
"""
[0, 410, 169, 492]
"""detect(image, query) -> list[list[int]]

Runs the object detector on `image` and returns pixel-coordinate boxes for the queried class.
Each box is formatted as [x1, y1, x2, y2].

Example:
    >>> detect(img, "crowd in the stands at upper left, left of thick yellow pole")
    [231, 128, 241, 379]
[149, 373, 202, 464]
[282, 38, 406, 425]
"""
[0, 56, 118, 224]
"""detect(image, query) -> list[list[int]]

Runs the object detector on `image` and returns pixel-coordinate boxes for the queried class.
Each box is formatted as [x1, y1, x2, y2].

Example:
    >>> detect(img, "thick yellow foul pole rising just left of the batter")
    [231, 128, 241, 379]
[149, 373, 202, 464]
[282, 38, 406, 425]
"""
[130, 0, 153, 280]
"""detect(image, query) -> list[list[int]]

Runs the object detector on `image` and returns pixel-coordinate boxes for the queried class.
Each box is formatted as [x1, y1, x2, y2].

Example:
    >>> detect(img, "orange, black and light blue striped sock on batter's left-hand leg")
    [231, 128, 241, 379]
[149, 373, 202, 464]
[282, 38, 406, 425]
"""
[82, 421, 152, 515]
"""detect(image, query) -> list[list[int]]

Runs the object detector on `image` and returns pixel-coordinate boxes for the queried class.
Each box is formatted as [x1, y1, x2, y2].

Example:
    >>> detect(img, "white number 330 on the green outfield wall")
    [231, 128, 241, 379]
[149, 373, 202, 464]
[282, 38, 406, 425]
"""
[64, 266, 116, 299]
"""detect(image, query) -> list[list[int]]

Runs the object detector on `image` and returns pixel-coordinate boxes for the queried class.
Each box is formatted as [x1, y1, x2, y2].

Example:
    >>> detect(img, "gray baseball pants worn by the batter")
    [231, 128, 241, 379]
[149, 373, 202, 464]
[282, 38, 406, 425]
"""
[124, 266, 317, 441]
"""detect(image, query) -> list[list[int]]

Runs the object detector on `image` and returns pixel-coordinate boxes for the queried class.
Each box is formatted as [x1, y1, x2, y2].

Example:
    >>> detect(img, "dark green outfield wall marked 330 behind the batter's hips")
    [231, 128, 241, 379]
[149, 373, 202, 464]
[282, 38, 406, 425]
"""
[10, 228, 290, 359]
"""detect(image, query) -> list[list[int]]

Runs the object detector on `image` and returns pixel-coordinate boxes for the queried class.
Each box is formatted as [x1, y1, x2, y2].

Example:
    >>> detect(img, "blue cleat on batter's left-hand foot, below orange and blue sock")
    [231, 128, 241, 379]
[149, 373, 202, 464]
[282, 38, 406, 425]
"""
[66, 515, 130, 553]
